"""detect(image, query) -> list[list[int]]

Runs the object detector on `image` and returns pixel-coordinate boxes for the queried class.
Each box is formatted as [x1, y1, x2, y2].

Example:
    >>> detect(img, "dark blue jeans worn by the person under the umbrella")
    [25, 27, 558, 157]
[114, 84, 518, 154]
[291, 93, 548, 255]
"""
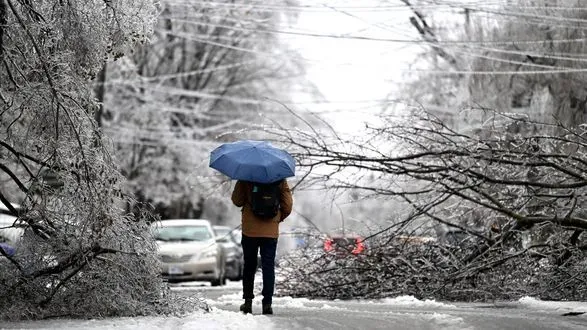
[241, 235, 277, 304]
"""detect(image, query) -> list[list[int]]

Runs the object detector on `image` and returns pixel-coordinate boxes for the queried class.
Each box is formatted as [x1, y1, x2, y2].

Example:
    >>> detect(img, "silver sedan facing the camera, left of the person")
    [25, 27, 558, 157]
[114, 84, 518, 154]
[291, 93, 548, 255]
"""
[152, 219, 226, 286]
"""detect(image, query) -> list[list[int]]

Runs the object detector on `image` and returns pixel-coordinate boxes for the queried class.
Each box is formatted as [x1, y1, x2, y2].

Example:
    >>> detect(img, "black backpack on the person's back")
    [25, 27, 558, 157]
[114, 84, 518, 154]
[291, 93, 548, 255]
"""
[251, 181, 281, 219]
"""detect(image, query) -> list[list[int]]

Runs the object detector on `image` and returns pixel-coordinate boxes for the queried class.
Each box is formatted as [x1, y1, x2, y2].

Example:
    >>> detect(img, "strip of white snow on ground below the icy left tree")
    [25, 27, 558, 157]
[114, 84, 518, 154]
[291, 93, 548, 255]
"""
[0, 308, 275, 330]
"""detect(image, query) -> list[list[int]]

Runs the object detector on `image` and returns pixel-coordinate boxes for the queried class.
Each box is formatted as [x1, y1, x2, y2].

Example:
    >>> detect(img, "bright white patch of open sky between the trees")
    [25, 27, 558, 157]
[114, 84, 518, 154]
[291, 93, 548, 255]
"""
[285, 0, 421, 131]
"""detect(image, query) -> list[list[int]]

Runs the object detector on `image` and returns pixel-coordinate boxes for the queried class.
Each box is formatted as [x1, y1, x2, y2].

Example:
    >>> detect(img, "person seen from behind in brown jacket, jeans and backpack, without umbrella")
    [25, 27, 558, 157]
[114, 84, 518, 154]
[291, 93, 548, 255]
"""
[232, 179, 293, 314]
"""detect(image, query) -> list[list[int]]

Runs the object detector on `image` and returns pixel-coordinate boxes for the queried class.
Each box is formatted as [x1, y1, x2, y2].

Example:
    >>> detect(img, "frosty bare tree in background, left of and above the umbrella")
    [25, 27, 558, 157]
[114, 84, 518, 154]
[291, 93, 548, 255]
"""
[103, 1, 312, 220]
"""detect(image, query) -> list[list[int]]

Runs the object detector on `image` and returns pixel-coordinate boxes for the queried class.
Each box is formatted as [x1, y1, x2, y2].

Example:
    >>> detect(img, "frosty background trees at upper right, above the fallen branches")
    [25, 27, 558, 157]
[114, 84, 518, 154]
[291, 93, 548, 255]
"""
[405, 0, 586, 126]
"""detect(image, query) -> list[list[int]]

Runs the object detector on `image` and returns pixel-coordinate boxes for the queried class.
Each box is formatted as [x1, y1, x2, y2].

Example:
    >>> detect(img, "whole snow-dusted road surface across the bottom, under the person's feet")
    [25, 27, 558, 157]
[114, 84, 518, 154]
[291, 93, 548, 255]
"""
[0, 282, 587, 330]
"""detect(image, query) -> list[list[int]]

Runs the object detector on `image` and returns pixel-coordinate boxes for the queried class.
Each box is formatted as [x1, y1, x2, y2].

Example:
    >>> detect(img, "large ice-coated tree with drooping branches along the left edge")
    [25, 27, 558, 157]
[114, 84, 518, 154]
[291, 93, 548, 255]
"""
[0, 0, 204, 319]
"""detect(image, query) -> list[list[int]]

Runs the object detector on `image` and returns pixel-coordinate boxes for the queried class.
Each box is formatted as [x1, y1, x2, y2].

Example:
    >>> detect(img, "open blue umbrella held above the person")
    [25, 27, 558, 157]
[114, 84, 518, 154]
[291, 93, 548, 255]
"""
[210, 140, 296, 183]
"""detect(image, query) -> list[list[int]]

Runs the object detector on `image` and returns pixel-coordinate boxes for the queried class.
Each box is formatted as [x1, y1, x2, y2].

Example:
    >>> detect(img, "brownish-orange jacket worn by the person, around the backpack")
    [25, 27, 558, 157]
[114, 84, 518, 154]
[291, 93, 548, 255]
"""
[232, 180, 293, 238]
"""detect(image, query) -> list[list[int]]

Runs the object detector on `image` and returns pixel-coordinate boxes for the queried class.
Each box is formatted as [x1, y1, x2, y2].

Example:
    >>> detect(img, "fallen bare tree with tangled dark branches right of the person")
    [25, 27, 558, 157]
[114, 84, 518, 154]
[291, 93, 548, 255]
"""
[276, 109, 587, 299]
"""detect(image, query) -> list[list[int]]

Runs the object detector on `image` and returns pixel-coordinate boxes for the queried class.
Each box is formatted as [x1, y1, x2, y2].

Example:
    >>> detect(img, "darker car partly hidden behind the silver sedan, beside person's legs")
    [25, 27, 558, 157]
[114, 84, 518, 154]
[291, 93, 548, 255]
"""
[213, 226, 244, 281]
